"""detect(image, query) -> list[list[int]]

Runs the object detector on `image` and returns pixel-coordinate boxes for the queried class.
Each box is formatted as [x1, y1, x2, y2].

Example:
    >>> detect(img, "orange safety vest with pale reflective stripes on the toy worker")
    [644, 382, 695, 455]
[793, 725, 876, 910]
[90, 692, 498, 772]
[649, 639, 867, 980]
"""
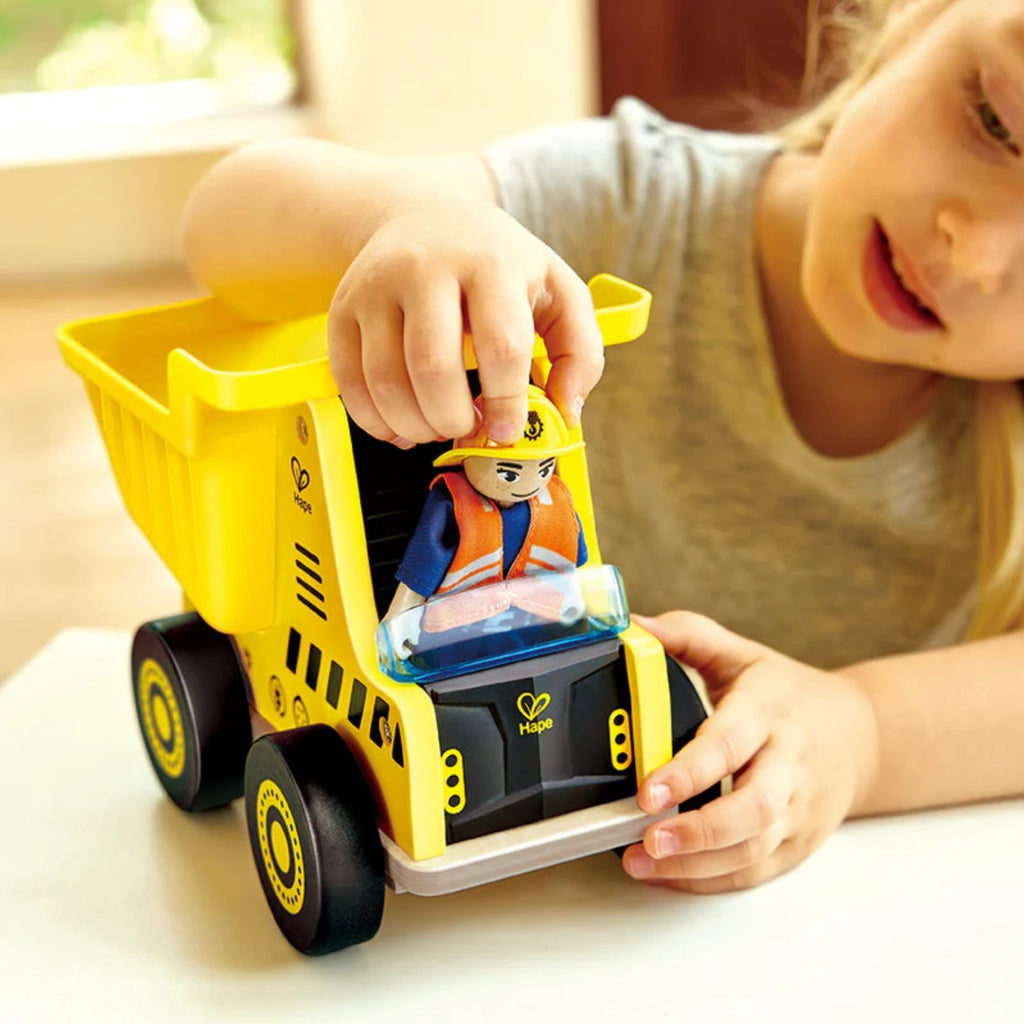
[422, 471, 580, 633]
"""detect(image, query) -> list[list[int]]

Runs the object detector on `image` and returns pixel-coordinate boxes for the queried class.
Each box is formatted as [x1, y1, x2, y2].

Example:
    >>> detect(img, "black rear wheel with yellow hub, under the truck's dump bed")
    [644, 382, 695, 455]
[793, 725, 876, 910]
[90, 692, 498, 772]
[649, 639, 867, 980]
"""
[131, 612, 252, 811]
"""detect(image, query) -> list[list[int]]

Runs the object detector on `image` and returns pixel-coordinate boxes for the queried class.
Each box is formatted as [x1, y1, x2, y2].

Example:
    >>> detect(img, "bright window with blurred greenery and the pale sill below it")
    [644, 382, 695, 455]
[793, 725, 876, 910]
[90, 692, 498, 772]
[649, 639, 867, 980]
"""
[0, 0, 308, 278]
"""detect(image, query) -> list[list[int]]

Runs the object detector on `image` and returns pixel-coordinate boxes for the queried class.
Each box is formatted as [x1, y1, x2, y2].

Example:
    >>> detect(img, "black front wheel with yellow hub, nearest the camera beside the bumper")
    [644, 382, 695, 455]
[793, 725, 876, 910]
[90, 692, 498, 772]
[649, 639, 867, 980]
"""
[246, 725, 384, 955]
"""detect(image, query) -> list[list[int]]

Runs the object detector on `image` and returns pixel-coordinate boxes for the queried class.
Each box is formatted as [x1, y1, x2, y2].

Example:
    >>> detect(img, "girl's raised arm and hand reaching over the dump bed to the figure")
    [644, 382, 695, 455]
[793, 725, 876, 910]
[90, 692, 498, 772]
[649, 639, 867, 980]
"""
[182, 139, 603, 444]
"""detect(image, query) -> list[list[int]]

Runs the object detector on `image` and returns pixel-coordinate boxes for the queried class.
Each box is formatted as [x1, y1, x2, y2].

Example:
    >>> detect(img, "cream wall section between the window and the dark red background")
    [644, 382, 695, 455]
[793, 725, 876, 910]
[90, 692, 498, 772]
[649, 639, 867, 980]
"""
[306, 0, 597, 153]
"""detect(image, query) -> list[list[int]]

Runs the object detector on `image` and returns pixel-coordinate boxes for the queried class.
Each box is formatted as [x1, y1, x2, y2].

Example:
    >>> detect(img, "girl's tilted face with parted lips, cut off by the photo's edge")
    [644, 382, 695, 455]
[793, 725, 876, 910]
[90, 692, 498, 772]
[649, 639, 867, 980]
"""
[803, 0, 1024, 380]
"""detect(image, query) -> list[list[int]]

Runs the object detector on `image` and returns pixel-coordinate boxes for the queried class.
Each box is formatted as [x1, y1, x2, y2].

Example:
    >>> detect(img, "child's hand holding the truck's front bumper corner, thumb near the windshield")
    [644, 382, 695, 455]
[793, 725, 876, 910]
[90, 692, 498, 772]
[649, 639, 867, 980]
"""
[623, 611, 878, 893]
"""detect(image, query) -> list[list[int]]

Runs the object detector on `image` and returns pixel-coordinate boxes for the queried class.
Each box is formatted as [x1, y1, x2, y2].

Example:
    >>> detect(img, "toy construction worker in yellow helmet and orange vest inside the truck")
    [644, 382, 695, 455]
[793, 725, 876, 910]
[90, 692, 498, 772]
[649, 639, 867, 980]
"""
[385, 386, 587, 667]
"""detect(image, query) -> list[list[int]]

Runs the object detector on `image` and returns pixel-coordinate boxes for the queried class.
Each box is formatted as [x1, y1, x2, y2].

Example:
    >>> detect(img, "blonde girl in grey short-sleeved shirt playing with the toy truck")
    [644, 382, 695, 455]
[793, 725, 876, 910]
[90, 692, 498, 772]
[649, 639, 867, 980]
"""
[184, 0, 1024, 892]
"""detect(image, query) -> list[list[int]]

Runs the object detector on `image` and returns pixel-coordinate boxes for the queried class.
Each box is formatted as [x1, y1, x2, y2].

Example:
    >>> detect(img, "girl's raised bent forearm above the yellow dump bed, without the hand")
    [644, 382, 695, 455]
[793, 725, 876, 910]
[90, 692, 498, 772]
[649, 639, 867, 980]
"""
[182, 139, 495, 319]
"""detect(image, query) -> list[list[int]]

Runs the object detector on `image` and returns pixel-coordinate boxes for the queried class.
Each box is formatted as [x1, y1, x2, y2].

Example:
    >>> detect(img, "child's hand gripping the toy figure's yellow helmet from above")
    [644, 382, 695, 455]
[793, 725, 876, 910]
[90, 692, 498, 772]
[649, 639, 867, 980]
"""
[329, 194, 604, 447]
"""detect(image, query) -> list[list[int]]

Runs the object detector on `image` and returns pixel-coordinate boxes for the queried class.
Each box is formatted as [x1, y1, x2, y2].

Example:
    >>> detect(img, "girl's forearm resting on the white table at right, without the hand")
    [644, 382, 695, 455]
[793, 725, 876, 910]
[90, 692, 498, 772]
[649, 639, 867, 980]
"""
[843, 633, 1024, 816]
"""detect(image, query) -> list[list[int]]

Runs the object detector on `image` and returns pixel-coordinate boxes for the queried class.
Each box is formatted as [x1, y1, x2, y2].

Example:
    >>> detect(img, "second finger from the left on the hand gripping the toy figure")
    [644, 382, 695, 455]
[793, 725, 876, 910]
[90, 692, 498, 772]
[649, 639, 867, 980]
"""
[359, 303, 437, 443]
